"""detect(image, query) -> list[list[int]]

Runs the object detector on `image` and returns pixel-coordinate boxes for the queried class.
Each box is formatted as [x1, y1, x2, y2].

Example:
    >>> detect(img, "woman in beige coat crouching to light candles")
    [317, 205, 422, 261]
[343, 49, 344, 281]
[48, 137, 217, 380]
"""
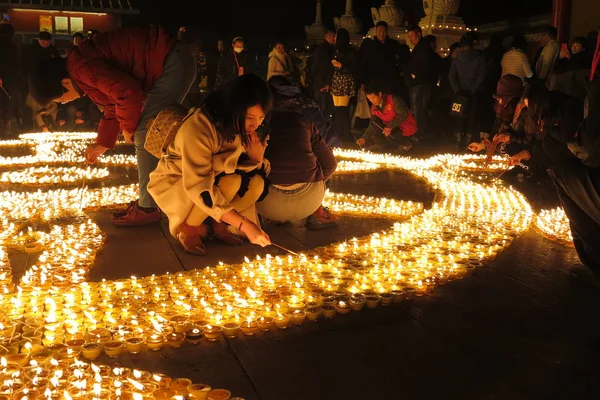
[148, 75, 272, 255]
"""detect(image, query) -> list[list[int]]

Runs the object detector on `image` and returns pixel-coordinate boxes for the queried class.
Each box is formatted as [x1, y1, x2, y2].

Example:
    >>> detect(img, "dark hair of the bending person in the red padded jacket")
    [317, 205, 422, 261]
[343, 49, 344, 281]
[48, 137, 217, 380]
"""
[29, 58, 69, 105]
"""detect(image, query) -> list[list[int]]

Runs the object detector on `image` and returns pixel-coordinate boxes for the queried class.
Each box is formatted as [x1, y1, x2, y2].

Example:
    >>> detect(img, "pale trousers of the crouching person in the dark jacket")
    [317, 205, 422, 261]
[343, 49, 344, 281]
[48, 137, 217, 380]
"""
[256, 181, 325, 223]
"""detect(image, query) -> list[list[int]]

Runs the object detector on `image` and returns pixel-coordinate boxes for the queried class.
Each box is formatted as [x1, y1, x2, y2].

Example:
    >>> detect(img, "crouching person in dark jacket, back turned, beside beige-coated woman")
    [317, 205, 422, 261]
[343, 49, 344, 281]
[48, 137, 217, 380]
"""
[256, 79, 338, 229]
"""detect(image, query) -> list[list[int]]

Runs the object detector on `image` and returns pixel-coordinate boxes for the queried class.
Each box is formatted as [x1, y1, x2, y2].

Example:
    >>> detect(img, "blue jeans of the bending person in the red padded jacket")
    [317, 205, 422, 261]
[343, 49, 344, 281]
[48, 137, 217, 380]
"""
[134, 43, 196, 208]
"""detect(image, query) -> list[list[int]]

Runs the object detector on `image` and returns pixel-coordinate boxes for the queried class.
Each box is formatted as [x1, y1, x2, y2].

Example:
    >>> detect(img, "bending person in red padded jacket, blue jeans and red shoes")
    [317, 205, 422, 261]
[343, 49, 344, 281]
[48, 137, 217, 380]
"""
[32, 26, 196, 226]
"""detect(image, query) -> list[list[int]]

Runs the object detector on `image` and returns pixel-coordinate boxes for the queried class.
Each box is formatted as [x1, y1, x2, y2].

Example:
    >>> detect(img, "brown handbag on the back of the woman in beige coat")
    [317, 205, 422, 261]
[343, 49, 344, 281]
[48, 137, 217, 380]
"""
[144, 104, 191, 158]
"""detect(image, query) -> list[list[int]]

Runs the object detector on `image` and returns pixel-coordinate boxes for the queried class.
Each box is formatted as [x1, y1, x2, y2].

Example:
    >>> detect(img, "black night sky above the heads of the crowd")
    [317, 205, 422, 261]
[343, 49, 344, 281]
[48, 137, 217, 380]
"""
[131, 0, 552, 51]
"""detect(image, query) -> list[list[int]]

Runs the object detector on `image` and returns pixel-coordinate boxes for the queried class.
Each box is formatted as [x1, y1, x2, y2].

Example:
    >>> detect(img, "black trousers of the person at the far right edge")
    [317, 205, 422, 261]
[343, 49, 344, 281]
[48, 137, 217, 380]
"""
[552, 159, 600, 276]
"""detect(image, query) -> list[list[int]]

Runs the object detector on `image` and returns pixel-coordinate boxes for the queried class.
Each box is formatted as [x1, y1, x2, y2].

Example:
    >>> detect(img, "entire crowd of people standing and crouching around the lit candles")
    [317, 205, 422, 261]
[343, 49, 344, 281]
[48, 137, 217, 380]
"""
[0, 22, 600, 273]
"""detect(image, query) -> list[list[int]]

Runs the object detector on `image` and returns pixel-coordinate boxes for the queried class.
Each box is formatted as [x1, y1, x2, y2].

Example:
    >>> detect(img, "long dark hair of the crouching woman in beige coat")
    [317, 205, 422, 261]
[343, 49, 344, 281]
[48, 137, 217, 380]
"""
[202, 74, 273, 144]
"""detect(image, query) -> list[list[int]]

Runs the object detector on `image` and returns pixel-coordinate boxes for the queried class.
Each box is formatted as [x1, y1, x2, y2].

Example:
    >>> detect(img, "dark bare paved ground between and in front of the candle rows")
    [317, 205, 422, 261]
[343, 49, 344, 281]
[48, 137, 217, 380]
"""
[8, 145, 600, 400]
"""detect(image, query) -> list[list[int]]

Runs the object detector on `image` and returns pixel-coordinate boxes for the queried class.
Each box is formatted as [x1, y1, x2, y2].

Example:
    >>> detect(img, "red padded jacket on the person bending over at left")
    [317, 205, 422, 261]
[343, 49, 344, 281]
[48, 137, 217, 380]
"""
[67, 26, 173, 148]
